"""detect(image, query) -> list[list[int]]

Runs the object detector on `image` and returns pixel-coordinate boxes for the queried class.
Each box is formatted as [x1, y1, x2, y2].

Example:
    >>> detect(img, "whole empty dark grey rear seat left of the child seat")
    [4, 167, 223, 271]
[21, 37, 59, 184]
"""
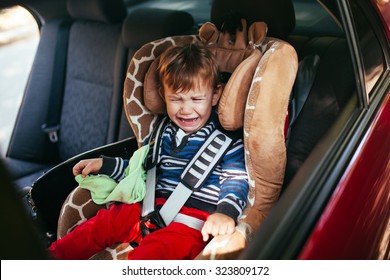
[4, 0, 127, 189]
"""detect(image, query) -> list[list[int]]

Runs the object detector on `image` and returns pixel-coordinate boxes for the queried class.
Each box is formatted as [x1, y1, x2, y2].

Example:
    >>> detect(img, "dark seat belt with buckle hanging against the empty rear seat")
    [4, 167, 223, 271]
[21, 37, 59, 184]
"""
[41, 20, 72, 143]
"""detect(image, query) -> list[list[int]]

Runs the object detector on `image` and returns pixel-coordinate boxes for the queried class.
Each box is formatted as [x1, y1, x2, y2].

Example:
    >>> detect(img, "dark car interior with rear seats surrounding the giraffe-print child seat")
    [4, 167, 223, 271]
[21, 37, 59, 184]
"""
[3, 0, 356, 258]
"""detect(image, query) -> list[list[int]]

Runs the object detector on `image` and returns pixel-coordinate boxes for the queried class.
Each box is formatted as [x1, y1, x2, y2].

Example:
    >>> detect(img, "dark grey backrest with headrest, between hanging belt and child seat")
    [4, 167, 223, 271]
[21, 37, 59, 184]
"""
[59, 0, 126, 160]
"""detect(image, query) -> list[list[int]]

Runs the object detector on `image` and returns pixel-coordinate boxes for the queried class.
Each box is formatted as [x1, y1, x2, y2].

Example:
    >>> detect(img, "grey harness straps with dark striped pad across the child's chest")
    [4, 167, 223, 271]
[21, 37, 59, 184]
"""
[141, 118, 235, 227]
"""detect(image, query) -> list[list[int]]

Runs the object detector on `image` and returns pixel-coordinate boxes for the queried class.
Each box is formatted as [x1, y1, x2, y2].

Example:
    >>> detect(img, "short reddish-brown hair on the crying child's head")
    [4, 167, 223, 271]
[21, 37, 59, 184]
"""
[157, 43, 219, 92]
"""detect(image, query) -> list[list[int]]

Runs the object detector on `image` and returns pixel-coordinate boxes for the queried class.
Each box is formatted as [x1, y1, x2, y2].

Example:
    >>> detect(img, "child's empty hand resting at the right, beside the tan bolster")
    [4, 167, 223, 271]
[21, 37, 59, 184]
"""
[202, 213, 236, 241]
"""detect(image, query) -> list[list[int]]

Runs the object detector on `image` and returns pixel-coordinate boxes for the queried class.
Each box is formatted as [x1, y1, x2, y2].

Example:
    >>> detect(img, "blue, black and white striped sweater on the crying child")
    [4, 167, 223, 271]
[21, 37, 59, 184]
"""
[100, 111, 248, 220]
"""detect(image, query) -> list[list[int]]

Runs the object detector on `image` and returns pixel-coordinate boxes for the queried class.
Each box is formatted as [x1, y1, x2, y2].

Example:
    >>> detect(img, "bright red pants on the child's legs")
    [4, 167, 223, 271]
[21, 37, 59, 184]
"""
[49, 200, 208, 260]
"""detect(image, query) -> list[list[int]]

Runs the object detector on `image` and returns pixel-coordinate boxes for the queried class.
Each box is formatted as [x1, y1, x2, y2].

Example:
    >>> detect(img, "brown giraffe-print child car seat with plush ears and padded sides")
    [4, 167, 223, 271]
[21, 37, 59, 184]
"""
[54, 1, 298, 259]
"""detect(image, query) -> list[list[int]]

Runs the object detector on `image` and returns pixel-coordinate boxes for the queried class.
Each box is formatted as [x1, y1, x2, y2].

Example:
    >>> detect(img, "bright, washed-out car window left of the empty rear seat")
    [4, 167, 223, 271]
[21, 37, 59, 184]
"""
[0, 6, 39, 155]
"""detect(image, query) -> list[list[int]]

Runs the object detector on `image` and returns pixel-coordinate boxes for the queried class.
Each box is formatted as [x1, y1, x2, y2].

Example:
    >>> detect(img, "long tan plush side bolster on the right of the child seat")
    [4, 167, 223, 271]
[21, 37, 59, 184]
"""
[239, 38, 298, 238]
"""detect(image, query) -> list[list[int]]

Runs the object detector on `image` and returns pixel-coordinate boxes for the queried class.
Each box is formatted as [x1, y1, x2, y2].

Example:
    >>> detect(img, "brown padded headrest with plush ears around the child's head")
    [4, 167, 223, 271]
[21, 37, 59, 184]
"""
[144, 20, 267, 130]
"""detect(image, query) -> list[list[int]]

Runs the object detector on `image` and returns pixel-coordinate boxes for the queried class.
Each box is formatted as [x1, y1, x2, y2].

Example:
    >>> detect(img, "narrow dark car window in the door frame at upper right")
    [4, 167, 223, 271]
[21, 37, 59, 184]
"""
[350, 1, 386, 98]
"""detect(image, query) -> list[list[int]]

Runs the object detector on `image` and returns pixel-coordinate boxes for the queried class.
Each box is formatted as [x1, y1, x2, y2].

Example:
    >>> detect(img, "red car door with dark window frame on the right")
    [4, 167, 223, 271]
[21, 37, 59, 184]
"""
[243, 0, 390, 259]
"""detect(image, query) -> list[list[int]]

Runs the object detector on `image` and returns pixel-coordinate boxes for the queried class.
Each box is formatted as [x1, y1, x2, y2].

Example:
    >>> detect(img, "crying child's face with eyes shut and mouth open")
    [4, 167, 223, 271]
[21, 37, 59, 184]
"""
[161, 82, 221, 133]
